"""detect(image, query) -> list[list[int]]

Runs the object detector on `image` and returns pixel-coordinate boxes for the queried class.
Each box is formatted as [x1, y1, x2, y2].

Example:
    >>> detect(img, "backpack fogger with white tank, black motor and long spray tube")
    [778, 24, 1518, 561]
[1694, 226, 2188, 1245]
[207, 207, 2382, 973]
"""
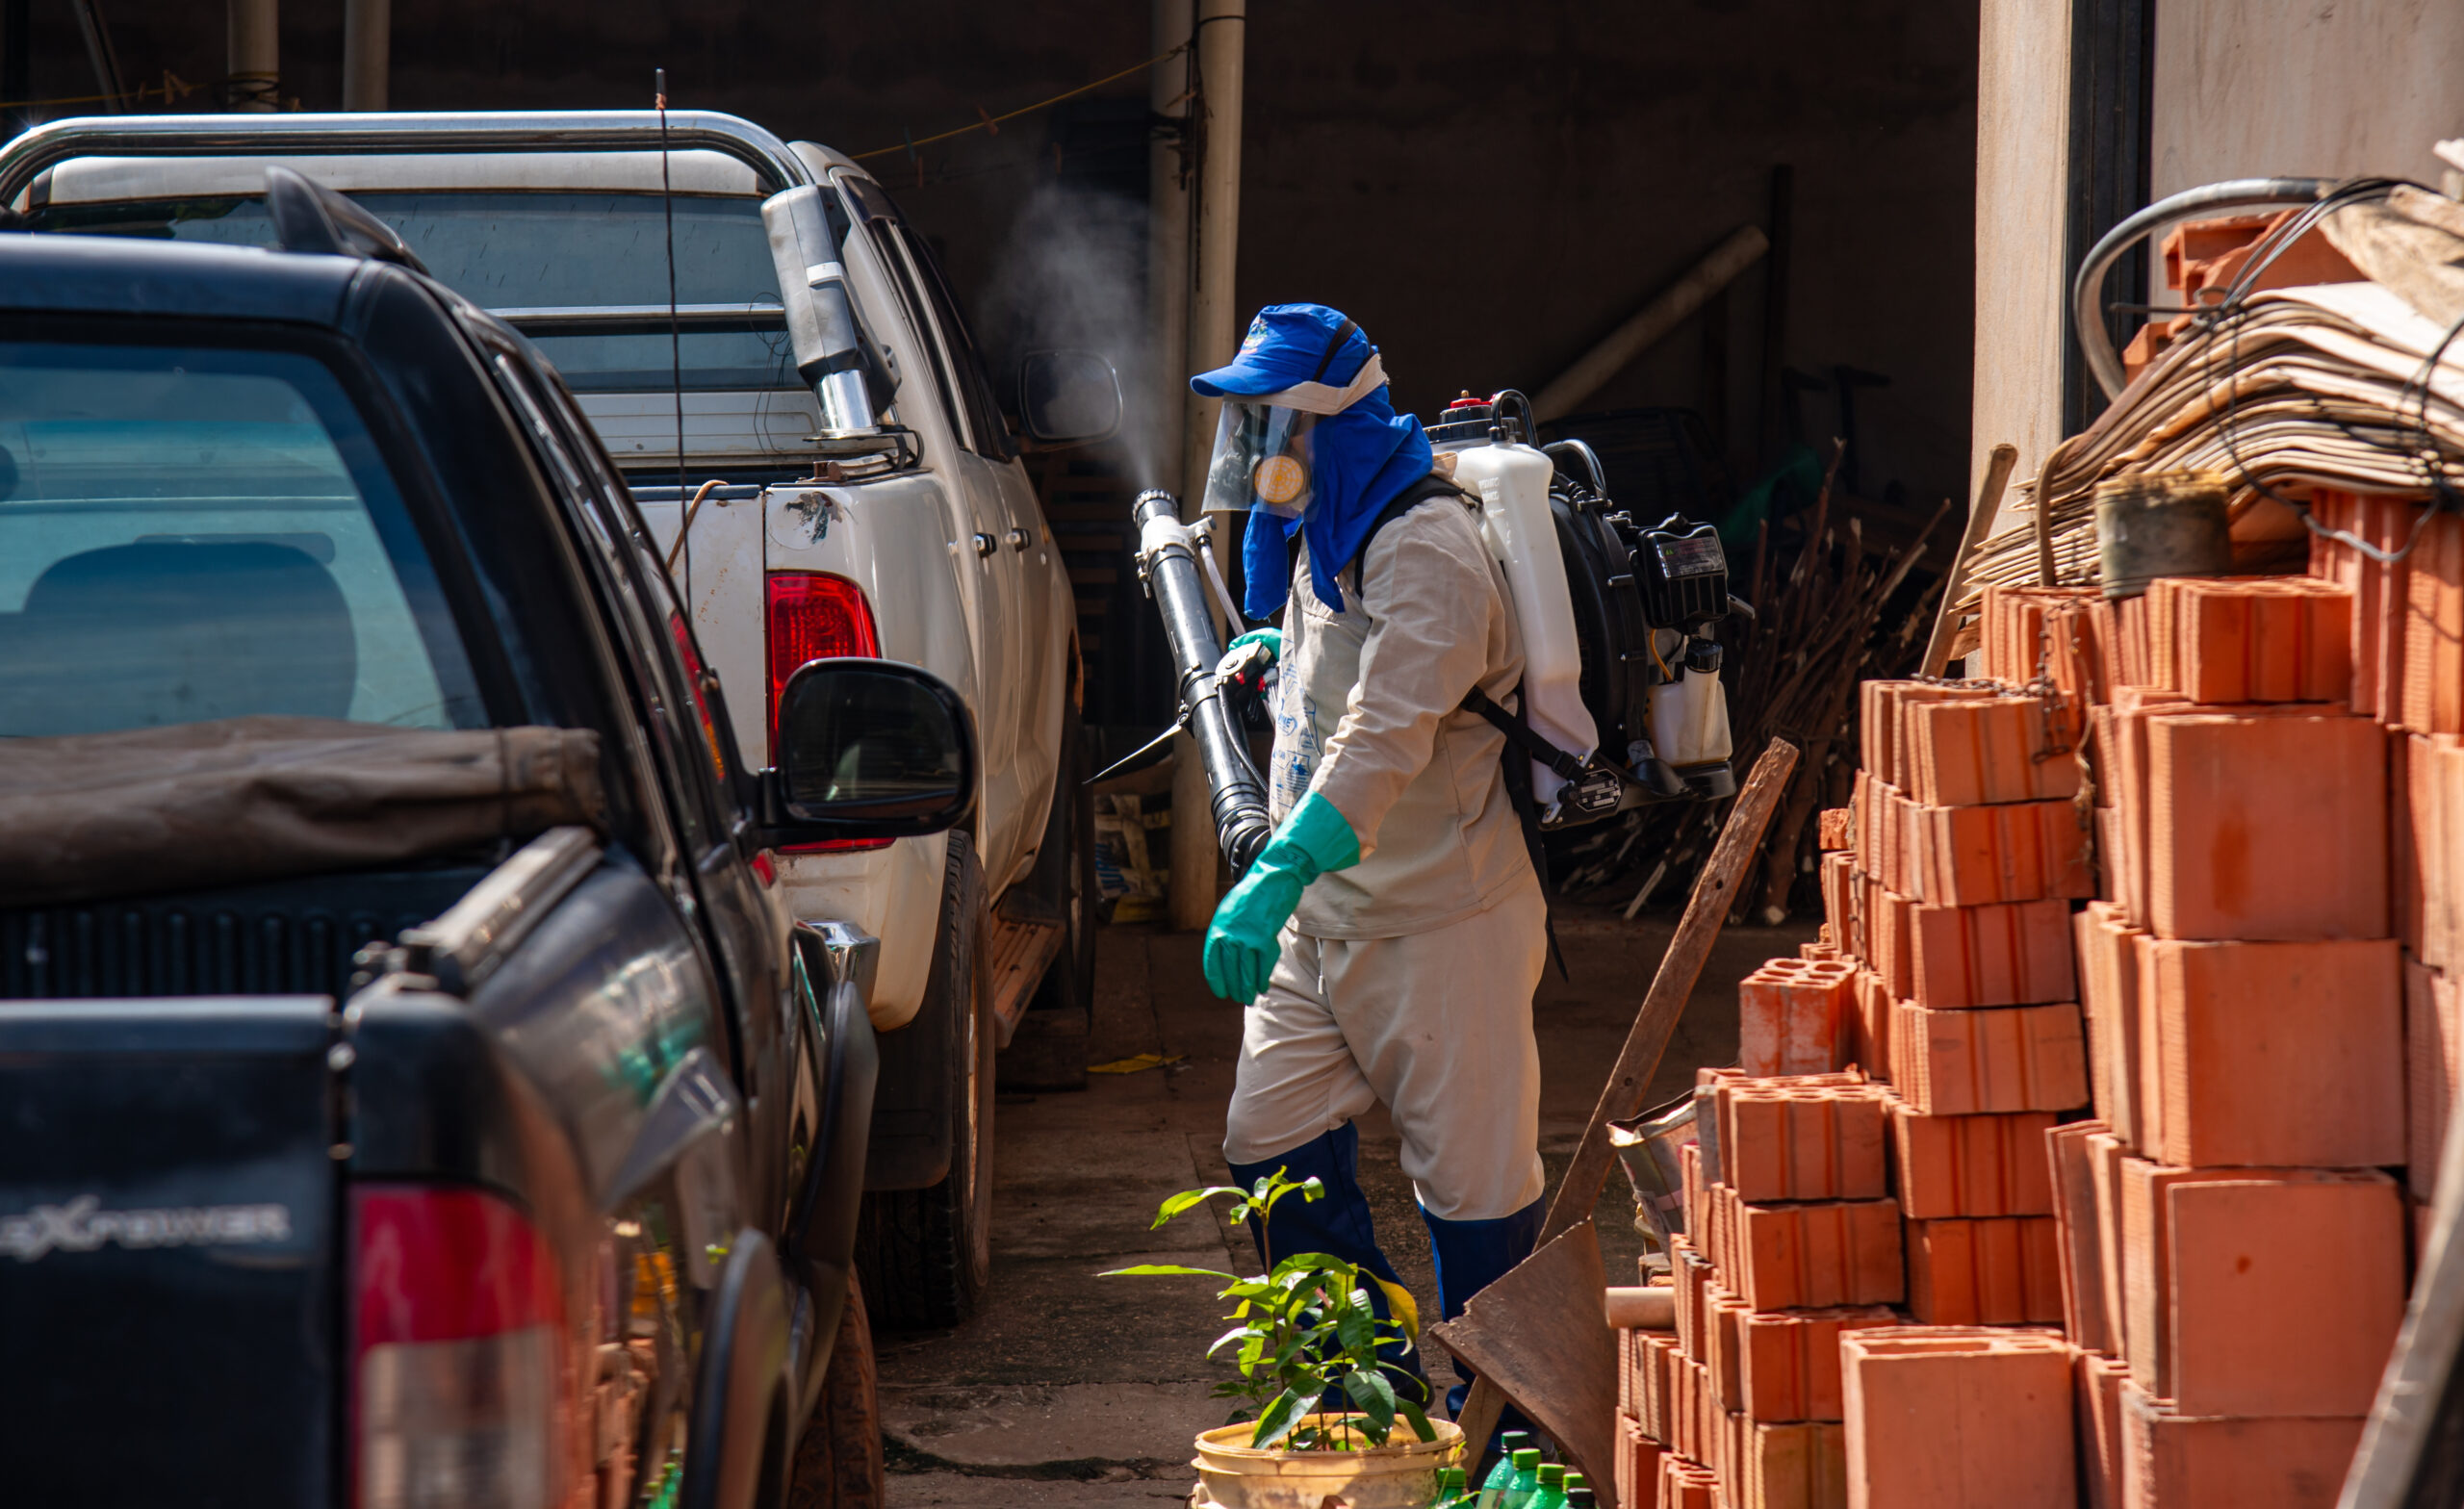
[1123, 390, 1752, 873]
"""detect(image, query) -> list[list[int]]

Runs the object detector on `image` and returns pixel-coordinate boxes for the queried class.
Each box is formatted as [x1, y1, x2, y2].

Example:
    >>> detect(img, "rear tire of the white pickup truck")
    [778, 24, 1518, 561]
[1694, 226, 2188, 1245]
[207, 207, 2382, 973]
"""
[855, 833, 993, 1332]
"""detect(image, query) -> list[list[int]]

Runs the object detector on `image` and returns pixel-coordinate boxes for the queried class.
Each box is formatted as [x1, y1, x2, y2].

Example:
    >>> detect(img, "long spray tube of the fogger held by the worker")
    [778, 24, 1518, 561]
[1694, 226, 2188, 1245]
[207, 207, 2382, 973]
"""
[1128, 488, 1274, 878]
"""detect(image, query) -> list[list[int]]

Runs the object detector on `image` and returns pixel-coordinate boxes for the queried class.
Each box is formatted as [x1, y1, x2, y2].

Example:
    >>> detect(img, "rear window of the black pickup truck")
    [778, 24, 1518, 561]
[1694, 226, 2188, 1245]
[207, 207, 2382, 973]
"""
[0, 343, 488, 737]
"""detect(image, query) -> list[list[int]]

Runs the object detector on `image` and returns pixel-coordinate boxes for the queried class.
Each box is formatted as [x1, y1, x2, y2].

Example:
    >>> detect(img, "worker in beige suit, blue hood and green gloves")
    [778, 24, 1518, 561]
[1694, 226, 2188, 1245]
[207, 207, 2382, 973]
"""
[1190, 303, 1548, 1408]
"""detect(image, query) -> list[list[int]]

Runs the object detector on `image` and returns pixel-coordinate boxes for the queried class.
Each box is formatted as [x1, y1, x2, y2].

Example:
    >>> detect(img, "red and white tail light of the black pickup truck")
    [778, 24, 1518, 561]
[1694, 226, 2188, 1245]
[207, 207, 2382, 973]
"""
[352, 1186, 569, 1509]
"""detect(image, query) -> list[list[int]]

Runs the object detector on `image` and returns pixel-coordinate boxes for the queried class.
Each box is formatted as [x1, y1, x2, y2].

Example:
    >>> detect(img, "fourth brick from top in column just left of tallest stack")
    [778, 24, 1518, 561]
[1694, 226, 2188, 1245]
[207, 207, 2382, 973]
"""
[1890, 1001, 2087, 1117]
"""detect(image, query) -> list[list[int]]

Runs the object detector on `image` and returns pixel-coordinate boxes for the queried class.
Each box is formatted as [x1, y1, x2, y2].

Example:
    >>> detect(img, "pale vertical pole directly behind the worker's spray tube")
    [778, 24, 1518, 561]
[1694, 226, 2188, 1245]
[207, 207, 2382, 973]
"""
[1173, 0, 1249, 930]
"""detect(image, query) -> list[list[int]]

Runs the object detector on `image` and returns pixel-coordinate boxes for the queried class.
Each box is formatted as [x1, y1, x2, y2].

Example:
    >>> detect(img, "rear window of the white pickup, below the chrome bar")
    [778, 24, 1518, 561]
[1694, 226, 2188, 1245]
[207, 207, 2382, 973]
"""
[35, 190, 801, 392]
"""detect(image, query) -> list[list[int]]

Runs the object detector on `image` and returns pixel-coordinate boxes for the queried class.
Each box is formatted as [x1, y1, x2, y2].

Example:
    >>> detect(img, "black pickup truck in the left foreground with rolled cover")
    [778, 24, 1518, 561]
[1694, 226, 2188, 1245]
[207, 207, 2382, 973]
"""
[0, 167, 976, 1509]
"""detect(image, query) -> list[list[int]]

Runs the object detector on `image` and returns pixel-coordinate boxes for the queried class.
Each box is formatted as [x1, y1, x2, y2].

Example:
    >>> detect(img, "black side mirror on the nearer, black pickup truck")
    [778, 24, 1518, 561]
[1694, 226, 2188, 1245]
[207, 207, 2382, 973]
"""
[758, 656, 976, 846]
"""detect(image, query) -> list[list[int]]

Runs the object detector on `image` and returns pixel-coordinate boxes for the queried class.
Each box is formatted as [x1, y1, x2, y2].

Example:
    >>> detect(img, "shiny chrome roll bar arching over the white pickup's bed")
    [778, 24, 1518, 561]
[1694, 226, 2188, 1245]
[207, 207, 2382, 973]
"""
[0, 111, 813, 205]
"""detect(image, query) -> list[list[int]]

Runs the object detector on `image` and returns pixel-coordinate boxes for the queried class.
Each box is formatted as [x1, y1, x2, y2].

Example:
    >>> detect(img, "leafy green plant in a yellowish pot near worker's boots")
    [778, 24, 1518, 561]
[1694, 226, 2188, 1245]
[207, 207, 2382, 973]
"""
[1104, 1168, 1464, 1509]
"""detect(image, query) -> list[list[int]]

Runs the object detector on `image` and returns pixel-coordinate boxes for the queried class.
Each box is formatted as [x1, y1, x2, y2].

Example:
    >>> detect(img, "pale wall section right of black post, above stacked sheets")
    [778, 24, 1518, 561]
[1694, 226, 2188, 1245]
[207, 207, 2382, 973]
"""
[2153, 0, 2464, 197]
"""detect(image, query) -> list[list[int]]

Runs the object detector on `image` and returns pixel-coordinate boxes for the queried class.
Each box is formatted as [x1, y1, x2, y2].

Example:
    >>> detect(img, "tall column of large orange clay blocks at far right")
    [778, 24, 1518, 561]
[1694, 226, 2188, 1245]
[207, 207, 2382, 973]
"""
[1984, 577, 2404, 1509]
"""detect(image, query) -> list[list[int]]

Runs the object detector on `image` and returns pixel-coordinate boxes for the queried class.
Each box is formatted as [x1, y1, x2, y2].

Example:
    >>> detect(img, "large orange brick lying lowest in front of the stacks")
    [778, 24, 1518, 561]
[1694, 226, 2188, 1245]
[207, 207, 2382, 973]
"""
[1840, 1326, 2077, 1509]
